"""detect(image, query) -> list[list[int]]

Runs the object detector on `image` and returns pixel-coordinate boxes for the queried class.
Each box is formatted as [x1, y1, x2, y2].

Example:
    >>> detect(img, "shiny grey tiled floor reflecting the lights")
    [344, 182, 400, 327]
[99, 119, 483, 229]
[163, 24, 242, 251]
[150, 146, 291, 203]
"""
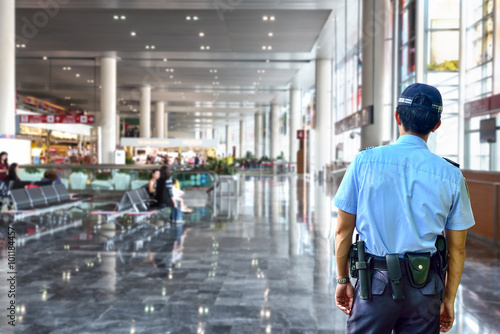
[0, 177, 500, 334]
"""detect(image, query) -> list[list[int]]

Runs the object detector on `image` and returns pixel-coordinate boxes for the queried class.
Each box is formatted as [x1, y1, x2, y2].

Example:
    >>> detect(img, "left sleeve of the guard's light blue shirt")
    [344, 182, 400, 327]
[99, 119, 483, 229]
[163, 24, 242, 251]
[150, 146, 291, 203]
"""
[333, 154, 359, 215]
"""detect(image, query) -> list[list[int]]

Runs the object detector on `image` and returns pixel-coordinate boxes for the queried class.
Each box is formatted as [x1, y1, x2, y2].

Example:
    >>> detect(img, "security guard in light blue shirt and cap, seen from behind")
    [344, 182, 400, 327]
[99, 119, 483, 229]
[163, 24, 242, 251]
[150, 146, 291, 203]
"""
[334, 83, 474, 334]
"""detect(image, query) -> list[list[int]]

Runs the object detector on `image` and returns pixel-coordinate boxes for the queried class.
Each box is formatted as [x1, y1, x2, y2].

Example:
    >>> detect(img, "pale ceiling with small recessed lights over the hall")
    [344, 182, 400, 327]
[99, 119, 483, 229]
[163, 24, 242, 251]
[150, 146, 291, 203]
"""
[16, 0, 344, 130]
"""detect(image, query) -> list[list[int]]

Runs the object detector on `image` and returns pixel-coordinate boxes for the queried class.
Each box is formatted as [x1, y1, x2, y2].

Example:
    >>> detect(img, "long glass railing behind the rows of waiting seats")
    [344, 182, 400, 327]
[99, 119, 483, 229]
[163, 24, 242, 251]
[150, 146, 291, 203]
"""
[17, 164, 219, 193]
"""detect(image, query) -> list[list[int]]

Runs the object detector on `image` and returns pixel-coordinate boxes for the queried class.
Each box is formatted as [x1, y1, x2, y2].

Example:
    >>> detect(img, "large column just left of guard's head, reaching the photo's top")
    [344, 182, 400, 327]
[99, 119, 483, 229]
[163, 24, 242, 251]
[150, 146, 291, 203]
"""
[361, 0, 392, 149]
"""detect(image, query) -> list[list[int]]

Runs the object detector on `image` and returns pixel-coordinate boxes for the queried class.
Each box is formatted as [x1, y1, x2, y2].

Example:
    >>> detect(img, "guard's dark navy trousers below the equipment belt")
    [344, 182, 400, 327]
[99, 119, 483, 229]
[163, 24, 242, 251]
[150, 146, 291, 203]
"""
[346, 270, 443, 334]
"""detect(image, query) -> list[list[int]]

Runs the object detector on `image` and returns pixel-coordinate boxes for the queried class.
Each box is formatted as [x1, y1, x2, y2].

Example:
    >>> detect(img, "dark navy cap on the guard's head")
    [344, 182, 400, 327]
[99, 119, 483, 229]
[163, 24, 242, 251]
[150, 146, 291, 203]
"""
[398, 83, 443, 114]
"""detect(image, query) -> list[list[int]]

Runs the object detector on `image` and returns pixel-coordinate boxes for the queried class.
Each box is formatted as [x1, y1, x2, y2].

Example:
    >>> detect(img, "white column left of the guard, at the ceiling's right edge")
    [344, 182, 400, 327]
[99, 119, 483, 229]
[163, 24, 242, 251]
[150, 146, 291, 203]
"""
[314, 59, 333, 176]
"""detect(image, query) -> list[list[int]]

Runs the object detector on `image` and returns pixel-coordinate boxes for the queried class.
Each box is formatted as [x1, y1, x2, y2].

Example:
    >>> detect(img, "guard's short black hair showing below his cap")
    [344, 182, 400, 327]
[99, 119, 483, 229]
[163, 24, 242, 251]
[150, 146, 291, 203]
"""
[396, 95, 441, 135]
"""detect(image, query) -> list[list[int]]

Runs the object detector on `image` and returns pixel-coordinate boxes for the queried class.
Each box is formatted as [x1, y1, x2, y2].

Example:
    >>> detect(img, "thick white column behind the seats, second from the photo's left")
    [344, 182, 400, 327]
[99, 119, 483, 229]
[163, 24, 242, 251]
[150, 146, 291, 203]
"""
[100, 57, 116, 164]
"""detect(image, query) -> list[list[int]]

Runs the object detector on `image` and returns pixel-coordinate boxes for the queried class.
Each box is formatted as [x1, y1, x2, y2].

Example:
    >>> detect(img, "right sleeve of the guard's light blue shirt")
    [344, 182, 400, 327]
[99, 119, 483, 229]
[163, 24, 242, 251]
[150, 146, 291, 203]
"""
[445, 178, 475, 231]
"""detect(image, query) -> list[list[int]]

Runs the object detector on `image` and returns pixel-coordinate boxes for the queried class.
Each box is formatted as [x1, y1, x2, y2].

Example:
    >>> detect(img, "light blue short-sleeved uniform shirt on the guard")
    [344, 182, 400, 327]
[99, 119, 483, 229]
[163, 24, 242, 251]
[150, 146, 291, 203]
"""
[334, 135, 474, 256]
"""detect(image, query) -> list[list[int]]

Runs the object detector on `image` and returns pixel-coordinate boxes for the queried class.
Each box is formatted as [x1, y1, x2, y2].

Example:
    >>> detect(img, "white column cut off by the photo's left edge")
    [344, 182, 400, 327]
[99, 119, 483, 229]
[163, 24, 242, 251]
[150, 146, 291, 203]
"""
[0, 0, 16, 137]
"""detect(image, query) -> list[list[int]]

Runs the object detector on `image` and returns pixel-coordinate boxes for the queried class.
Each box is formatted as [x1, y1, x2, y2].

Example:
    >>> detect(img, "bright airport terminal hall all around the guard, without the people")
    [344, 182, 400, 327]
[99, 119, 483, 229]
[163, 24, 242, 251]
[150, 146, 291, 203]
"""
[0, 0, 500, 334]
